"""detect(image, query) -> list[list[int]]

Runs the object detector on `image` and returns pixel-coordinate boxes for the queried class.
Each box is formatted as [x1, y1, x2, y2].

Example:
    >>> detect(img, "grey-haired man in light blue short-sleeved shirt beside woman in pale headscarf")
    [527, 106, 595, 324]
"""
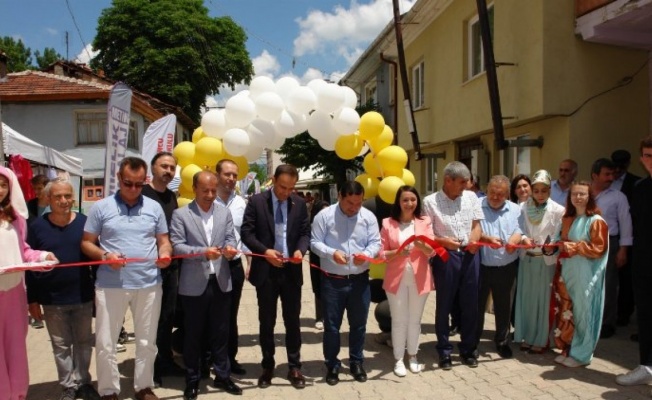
[477, 175, 522, 358]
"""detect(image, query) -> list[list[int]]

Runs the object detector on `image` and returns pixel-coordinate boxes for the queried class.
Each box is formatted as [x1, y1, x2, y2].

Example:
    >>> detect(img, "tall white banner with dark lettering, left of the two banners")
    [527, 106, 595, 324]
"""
[104, 82, 131, 197]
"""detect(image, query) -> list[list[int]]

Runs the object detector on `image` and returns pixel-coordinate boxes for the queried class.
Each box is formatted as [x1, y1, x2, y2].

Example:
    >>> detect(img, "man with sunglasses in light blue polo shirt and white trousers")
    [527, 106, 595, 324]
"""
[81, 157, 172, 400]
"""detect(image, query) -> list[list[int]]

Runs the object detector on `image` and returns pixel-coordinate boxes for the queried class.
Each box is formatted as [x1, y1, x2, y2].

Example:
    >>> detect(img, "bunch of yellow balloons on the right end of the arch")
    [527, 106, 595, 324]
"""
[352, 111, 415, 204]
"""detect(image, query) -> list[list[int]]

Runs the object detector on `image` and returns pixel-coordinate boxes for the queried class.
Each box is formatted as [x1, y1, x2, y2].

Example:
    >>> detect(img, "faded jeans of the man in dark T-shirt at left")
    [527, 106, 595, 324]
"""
[43, 301, 95, 388]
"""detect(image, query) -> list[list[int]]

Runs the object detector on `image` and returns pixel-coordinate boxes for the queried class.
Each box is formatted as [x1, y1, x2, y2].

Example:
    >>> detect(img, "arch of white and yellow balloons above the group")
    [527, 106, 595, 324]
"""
[174, 76, 411, 204]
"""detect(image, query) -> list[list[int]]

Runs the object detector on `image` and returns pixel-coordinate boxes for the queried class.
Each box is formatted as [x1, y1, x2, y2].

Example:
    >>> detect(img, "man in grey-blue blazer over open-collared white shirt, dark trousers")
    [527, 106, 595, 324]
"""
[170, 171, 242, 400]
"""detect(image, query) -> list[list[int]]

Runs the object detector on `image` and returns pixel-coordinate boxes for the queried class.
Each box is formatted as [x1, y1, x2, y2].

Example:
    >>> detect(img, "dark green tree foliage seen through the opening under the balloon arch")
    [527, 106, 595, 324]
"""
[276, 102, 380, 186]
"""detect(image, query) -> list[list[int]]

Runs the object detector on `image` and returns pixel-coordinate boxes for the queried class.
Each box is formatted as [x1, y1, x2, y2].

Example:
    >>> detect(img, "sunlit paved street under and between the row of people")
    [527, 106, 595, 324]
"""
[26, 265, 651, 400]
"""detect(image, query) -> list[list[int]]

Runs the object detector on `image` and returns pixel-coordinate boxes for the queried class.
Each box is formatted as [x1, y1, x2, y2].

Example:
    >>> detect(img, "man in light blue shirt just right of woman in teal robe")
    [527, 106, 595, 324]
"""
[591, 158, 633, 339]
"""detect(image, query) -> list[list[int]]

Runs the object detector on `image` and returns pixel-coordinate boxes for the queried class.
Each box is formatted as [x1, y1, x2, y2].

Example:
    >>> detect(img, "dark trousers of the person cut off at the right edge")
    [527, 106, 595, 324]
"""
[633, 272, 652, 367]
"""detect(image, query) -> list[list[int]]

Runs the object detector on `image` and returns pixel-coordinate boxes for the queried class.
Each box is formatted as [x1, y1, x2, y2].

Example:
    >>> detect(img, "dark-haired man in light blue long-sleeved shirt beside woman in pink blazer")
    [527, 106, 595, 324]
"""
[310, 181, 380, 386]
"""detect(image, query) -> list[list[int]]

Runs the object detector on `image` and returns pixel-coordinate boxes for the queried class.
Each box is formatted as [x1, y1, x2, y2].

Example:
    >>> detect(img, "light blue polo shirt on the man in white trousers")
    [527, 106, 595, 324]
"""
[84, 191, 168, 289]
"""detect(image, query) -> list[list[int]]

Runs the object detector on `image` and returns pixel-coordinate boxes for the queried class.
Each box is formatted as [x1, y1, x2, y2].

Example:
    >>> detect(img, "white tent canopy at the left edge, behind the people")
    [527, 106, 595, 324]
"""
[2, 123, 84, 176]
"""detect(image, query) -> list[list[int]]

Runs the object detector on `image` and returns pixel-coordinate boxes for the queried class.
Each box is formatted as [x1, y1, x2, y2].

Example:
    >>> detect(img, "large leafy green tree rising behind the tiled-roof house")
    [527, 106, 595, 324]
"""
[91, 0, 253, 122]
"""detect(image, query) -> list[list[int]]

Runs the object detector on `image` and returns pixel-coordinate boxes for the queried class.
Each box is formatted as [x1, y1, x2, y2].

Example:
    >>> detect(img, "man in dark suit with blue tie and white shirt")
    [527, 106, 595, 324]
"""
[240, 164, 310, 389]
